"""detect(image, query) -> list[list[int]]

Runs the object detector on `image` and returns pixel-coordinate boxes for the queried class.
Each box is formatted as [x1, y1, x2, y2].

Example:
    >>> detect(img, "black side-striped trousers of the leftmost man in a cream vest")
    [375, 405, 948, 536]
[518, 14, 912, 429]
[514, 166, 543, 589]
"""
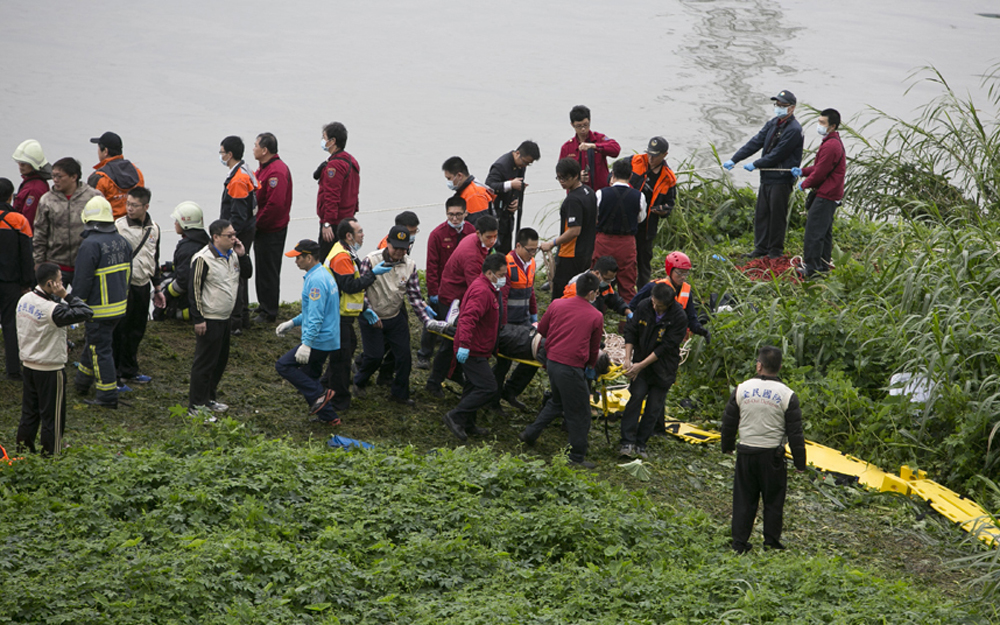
[17, 367, 66, 456]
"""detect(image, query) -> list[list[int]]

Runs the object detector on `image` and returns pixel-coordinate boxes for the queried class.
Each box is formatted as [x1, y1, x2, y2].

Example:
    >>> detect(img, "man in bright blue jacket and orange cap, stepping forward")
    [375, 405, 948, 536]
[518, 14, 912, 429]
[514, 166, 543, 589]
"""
[274, 239, 340, 425]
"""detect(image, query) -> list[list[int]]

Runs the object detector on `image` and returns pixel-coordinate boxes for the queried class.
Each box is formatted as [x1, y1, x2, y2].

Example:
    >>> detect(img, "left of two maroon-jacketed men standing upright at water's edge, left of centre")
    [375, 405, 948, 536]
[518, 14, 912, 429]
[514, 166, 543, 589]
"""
[253, 132, 292, 323]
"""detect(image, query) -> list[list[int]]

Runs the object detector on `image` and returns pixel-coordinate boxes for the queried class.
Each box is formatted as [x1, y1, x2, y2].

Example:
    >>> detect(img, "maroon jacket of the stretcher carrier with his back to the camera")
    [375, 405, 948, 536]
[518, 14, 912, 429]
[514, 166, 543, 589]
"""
[540, 297, 604, 369]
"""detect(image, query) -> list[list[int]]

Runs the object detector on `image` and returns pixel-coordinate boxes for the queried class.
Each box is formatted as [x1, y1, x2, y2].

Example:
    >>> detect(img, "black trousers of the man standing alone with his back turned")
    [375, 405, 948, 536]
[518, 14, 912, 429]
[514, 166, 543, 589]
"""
[733, 447, 788, 553]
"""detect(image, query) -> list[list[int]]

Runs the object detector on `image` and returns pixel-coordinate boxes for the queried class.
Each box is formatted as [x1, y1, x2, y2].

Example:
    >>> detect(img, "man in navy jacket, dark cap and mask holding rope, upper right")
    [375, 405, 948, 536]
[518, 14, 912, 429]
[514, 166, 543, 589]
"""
[722, 90, 803, 258]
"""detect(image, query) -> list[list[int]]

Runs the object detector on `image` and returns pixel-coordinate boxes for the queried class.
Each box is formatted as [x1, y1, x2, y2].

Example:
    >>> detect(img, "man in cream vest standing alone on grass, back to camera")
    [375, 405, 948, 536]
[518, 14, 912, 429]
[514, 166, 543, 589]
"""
[722, 345, 806, 554]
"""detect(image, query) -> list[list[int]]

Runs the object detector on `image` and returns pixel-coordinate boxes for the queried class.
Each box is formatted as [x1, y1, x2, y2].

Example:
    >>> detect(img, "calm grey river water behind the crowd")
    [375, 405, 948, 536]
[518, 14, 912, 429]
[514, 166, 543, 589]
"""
[0, 0, 1000, 300]
